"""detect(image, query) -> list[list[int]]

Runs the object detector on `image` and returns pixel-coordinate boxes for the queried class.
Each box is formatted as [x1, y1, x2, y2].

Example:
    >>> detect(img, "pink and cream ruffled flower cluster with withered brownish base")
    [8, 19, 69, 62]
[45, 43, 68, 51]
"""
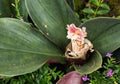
[67, 24, 93, 59]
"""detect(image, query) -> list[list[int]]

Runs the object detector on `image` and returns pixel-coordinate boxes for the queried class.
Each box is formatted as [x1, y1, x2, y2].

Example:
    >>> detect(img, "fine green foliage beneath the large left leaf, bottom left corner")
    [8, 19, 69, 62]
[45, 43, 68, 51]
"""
[0, 64, 63, 84]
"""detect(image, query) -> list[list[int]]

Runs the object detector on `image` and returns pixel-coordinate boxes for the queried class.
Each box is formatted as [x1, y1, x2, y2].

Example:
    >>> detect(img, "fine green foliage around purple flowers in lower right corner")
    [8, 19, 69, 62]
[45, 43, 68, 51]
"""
[89, 57, 120, 84]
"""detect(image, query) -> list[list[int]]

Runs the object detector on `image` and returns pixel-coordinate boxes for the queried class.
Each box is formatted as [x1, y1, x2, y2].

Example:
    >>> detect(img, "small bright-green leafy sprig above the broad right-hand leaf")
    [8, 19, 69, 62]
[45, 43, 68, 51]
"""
[82, 0, 110, 19]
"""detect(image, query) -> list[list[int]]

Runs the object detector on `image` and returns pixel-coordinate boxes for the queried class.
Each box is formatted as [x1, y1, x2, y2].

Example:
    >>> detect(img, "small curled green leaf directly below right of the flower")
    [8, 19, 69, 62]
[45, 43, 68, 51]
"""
[74, 51, 102, 74]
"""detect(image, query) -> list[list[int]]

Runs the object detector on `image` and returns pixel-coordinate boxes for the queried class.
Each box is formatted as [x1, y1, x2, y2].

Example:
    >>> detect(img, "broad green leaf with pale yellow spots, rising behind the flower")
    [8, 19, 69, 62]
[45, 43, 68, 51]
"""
[25, 0, 80, 49]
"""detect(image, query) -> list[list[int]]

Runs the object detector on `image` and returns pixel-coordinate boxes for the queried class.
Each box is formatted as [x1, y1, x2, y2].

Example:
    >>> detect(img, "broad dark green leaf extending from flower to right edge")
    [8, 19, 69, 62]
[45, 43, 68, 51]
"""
[82, 18, 120, 57]
